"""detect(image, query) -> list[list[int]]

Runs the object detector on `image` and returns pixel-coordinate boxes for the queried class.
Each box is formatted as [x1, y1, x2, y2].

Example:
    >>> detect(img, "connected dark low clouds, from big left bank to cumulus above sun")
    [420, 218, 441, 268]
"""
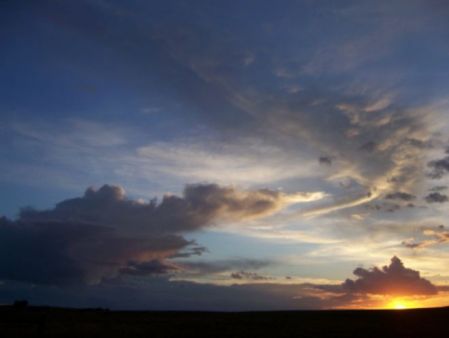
[0, 185, 438, 310]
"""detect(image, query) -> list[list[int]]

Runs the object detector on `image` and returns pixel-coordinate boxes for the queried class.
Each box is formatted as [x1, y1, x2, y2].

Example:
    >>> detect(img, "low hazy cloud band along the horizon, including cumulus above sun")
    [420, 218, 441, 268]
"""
[0, 257, 440, 311]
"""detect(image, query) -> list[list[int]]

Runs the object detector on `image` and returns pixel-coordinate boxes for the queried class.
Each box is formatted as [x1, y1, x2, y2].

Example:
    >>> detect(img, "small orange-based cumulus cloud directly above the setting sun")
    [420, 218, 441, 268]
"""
[341, 256, 437, 296]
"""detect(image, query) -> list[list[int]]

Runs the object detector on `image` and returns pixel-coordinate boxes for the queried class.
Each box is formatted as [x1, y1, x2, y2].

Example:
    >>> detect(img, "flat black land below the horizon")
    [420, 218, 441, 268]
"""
[0, 306, 449, 338]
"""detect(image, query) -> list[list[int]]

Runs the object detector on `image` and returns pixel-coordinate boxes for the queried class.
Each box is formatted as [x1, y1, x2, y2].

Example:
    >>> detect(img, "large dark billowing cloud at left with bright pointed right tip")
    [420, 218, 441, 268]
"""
[0, 184, 317, 284]
